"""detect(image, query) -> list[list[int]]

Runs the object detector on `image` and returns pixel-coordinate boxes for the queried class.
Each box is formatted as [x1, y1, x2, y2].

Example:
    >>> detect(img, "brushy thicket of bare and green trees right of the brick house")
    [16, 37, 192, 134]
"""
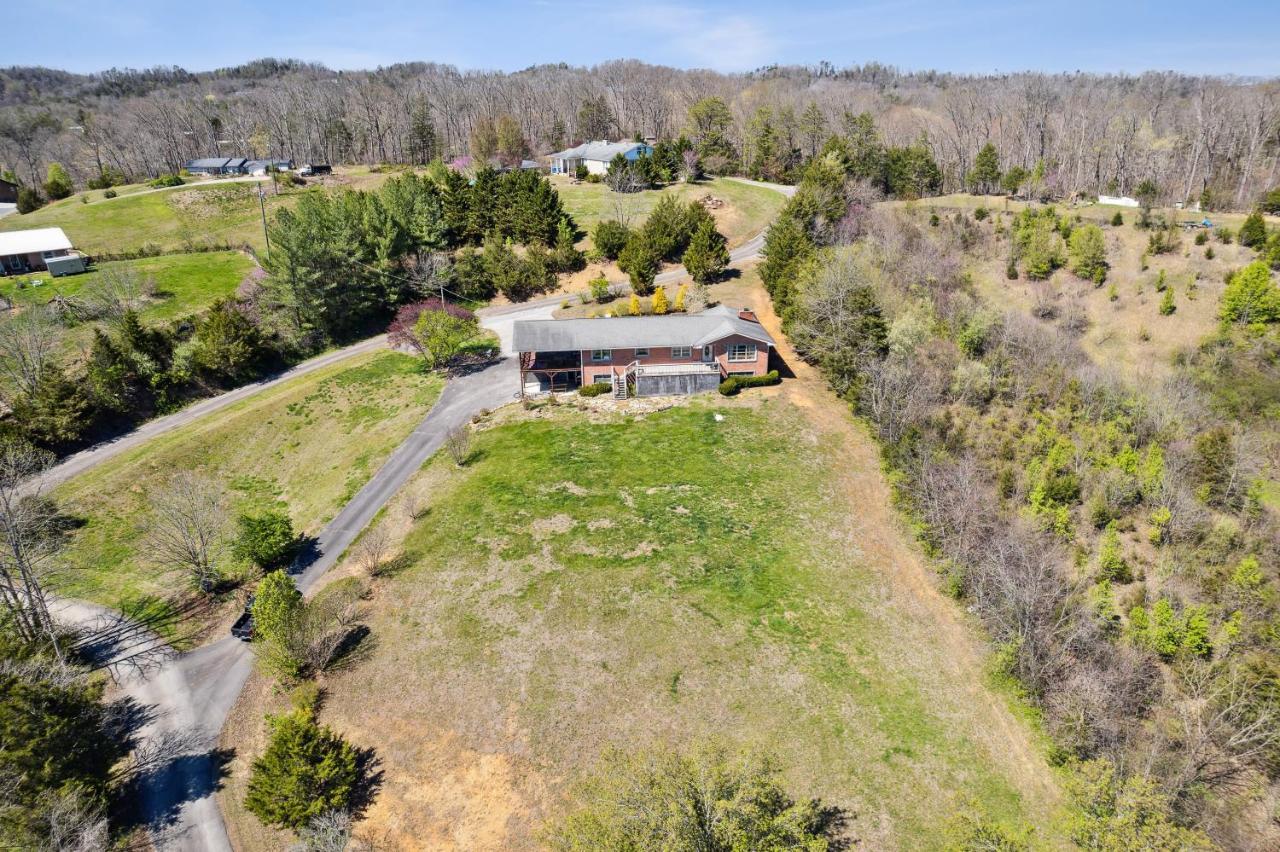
[762, 164, 1280, 848]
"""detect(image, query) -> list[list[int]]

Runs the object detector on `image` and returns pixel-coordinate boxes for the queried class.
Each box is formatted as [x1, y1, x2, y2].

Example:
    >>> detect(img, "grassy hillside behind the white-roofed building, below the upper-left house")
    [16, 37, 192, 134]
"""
[0, 183, 303, 255]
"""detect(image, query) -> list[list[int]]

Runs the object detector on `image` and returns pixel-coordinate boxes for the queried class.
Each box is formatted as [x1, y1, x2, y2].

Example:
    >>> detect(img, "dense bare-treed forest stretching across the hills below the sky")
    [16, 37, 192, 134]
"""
[0, 59, 1280, 209]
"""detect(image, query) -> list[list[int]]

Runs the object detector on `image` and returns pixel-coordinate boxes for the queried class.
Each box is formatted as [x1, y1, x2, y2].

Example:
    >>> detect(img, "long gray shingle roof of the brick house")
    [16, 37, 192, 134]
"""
[513, 304, 773, 352]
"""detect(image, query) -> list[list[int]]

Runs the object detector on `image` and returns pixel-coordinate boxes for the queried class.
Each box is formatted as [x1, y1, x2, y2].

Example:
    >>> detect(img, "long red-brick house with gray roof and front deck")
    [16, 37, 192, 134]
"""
[513, 306, 773, 397]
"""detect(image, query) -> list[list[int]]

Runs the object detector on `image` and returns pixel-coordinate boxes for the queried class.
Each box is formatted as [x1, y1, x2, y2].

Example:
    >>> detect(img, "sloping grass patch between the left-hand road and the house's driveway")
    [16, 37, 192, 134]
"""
[54, 352, 443, 609]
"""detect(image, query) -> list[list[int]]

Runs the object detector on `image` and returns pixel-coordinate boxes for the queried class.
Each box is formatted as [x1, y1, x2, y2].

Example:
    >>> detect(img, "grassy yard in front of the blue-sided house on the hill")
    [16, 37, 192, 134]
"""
[553, 178, 786, 247]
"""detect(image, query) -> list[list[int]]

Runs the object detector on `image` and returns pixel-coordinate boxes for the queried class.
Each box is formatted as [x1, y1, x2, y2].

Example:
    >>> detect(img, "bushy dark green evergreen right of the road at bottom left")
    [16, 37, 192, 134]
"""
[244, 710, 360, 829]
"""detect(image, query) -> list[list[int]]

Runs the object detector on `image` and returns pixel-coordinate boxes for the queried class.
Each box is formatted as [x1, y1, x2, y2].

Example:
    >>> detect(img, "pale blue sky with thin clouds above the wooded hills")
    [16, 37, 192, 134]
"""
[10, 0, 1280, 75]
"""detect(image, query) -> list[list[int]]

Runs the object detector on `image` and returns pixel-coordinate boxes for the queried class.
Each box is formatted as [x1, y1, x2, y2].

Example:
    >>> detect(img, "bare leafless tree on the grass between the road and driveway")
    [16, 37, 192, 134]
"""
[147, 471, 228, 591]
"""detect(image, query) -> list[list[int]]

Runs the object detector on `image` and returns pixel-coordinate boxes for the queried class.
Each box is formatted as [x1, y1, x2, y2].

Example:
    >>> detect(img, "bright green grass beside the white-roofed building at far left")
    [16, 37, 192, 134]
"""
[0, 252, 253, 321]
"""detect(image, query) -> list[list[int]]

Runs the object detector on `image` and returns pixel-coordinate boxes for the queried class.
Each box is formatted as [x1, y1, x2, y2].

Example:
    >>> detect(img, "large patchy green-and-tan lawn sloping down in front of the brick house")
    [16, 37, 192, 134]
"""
[325, 400, 1052, 848]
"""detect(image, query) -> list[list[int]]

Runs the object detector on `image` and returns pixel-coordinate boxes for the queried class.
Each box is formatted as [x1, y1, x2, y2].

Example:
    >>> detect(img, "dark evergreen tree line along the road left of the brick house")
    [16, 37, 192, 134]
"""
[0, 169, 584, 452]
